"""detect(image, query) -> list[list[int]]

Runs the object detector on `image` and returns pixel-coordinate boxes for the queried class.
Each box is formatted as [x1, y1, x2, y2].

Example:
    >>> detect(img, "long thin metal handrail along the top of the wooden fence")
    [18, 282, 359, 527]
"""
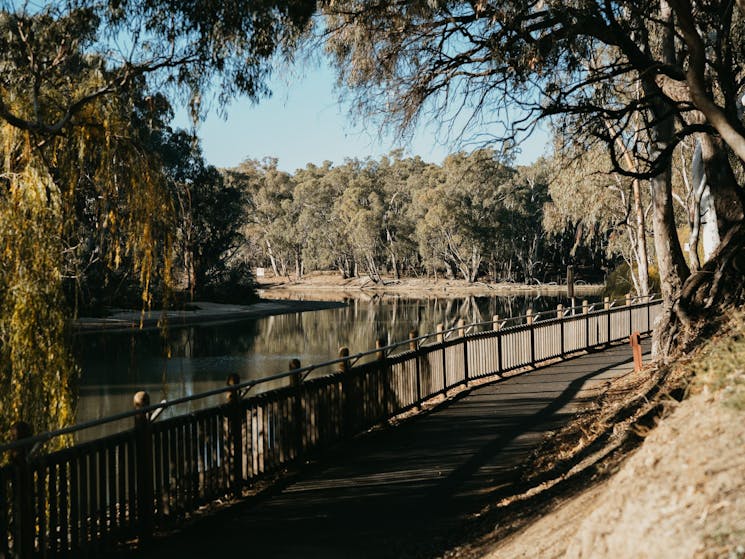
[0, 293, 657, 455]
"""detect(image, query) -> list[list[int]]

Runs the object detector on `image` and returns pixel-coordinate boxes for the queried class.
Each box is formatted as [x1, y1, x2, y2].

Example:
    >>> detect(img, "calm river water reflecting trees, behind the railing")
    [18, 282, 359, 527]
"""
[76, 296, 600, 438]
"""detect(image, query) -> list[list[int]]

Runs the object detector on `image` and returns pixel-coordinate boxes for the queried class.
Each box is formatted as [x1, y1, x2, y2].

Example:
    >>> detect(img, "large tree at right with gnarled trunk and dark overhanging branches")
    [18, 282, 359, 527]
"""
[324, 0, 745, 350]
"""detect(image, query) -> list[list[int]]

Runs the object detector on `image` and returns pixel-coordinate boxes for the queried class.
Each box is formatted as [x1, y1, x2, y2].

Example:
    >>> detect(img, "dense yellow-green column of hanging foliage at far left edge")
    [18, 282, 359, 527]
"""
[0, 161, 76, 439]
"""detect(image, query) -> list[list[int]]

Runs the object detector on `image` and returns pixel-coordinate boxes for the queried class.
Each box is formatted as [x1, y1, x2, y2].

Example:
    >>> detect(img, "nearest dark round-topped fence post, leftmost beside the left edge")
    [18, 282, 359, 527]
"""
[11, 421, 33, 559]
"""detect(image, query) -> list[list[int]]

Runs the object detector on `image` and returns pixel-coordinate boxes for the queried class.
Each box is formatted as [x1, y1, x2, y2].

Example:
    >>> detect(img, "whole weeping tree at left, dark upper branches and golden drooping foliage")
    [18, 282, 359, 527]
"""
[0, 0, 314, 446]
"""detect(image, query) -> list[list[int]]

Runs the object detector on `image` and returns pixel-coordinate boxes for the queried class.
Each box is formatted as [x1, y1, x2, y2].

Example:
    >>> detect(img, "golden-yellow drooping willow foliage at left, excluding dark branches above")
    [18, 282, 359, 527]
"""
[0, 83, 174, 444]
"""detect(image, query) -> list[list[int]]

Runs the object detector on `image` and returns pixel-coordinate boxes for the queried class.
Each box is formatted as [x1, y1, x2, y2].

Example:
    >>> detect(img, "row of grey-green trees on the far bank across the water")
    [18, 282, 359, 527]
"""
[223, 148, 620, 284]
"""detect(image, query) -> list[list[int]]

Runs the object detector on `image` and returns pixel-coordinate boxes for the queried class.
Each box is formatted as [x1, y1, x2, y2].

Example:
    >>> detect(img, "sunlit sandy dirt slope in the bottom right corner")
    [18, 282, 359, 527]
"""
[476, 317, 745, 559]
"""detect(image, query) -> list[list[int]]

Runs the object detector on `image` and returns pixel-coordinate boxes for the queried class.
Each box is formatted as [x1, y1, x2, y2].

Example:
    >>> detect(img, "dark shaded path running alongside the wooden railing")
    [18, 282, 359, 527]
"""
[138, 345, 644, 559]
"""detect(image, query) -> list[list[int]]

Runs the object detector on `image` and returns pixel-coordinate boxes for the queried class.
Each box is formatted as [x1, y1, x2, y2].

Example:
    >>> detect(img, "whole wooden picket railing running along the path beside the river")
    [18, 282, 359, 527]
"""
[0, 297, 659, 558]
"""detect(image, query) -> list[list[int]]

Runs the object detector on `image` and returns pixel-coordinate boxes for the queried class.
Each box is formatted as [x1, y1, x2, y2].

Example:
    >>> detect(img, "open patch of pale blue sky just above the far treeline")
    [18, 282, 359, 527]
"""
[175, 58, 546, 172]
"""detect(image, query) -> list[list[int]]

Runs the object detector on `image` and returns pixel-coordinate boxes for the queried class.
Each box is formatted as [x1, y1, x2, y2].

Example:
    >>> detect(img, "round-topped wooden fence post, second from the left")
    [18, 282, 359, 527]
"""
[133, 390, 155, 545]
